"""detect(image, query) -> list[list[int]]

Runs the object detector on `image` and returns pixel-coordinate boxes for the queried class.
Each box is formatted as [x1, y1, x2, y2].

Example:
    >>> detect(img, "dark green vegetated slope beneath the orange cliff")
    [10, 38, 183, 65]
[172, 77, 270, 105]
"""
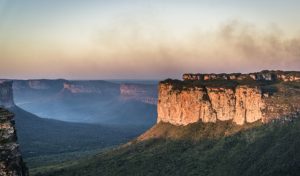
[36, 119, 300, 176]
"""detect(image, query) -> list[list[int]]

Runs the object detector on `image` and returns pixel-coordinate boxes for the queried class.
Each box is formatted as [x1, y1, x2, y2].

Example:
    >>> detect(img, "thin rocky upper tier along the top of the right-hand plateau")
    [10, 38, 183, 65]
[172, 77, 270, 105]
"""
[182, 70, 300, 82]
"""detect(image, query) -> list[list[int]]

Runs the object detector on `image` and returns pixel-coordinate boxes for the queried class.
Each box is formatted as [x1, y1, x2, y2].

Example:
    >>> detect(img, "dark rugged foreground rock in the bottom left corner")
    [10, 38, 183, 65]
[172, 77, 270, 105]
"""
[0, 108, 28, 176]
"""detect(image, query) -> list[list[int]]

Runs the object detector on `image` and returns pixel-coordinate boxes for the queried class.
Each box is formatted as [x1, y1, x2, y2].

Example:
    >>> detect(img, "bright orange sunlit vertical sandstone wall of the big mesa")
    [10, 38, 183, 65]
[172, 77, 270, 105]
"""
[157, 84, 265, 125]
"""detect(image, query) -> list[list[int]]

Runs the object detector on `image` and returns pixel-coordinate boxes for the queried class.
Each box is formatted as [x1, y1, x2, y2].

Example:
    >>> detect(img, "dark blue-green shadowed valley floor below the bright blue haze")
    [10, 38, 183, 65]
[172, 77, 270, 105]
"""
[10, 107, 146, 172]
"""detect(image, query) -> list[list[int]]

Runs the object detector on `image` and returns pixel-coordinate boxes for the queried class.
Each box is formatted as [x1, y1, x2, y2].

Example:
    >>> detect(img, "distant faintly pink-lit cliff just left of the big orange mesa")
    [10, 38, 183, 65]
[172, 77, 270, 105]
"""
[120, 84, 157, 105]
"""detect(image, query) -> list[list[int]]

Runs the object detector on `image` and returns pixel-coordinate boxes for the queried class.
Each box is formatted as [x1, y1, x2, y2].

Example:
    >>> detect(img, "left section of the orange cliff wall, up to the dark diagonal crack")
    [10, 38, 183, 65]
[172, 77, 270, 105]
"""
[157, 84, 217, 125]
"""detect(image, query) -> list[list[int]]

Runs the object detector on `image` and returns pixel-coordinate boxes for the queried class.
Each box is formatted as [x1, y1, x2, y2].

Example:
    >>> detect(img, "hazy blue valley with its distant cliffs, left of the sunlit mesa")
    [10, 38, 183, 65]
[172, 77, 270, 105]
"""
[0, 80, 157, 174]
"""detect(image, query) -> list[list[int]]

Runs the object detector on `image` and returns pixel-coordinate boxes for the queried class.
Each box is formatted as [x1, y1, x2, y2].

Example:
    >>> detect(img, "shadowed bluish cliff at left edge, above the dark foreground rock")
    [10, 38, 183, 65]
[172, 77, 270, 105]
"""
[0, 81, 14, 108]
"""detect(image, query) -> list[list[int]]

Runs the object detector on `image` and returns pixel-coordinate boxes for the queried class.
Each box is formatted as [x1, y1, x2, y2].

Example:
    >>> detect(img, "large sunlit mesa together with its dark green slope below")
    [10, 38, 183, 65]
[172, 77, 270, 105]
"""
[19, 71, 300, 176]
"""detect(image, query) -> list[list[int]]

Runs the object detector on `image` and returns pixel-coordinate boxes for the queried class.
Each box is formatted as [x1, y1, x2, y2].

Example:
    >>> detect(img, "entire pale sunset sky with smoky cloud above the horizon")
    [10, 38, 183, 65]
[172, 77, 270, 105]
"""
[0, 0, 300, 79]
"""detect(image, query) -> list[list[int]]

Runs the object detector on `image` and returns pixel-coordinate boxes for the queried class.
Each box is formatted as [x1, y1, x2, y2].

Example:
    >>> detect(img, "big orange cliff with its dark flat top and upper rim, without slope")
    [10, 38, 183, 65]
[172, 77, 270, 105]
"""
[157, 71, 300, 125]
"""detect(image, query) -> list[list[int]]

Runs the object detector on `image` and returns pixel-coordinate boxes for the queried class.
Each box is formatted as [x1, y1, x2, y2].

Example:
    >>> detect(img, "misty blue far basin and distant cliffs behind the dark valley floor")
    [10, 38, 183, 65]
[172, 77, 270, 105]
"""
[13, 79, 157, 126]
